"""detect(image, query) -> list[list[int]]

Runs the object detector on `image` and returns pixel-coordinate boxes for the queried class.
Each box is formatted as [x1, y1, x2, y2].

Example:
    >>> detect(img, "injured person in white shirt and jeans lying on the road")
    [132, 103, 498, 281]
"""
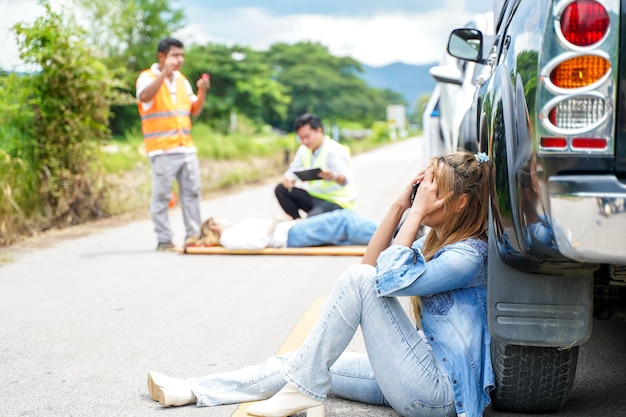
[196, 209, 378, 250]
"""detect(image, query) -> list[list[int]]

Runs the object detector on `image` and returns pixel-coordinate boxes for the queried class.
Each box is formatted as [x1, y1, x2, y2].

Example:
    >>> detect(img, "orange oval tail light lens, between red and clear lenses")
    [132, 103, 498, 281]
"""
[550, 55, 611, 88]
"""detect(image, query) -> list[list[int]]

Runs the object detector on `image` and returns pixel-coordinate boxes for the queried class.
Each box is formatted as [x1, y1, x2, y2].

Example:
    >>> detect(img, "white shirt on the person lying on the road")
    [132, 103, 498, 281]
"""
[220, 219, 296, 250]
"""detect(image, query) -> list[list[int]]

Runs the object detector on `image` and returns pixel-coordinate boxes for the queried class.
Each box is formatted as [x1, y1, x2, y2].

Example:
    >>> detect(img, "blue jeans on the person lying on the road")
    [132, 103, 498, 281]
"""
[287, 209, 377, 247]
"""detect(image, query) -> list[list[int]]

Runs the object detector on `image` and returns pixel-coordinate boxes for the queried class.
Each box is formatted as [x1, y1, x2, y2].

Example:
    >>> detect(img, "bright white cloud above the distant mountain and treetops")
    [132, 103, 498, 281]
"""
[178, 8, 471, 66]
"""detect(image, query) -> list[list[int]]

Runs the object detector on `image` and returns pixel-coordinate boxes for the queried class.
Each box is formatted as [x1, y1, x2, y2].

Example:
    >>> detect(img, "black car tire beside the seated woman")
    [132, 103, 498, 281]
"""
[491, 339, 578, 413]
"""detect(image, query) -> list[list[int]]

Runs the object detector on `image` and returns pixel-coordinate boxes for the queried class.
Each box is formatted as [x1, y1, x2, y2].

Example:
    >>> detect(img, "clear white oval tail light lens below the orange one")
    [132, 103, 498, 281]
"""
[548, 96, 606, 130]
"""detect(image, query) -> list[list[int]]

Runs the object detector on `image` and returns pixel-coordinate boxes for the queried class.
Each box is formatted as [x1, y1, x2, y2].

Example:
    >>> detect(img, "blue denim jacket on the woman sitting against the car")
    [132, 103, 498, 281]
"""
[376, 238, 494, 417]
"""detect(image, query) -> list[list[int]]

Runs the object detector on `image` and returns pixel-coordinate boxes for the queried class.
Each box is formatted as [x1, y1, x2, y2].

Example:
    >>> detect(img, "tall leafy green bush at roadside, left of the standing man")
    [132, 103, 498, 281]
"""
[14, 1, 125, 224]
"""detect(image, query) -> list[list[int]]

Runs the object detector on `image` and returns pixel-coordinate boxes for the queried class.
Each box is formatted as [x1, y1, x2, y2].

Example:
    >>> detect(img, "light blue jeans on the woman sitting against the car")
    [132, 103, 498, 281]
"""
[190, 265, 456, 417]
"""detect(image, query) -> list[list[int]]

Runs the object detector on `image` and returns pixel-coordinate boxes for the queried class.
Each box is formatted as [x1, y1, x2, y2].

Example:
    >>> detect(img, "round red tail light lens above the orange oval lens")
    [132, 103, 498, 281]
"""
[561, 0, 609, 46]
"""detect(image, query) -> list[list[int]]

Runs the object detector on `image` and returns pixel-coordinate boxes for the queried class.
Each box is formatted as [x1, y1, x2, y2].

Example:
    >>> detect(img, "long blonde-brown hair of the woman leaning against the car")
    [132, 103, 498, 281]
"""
[411, 151, 491, 325]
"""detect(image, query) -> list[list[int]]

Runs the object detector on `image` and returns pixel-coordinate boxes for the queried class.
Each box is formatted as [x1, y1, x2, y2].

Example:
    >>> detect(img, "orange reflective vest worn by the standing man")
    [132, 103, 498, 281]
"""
[138, 69, 193, 154]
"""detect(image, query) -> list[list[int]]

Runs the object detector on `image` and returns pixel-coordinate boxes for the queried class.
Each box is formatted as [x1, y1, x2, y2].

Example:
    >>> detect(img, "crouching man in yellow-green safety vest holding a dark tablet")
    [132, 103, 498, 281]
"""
[275, 113, 356, 219]
